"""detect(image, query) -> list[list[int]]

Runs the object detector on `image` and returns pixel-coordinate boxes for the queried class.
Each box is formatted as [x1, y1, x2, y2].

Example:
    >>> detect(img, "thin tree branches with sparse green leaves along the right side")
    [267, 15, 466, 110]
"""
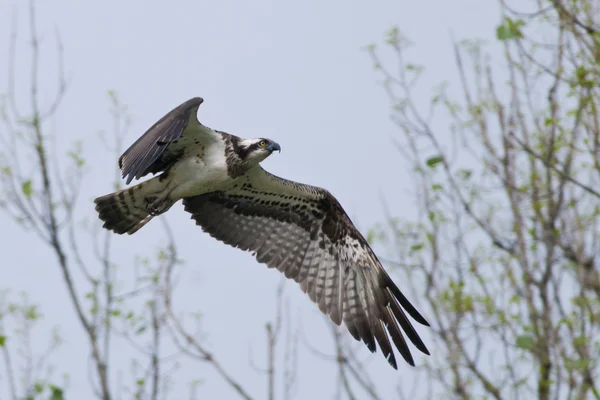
[369, 0, 600, 399]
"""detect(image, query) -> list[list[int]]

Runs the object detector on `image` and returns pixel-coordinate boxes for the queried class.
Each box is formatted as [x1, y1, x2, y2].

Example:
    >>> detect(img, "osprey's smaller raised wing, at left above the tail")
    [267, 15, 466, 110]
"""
[119, 97, 218, 184]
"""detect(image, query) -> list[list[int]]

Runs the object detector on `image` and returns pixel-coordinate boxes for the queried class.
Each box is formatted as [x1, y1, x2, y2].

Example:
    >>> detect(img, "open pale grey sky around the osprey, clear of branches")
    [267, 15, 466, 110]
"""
[0, 0, 499, 399]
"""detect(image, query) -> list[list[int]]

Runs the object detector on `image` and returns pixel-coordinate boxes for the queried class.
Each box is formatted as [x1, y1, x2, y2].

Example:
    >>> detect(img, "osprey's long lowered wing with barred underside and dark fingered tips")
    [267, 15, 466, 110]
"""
[183, 166, 429, 368]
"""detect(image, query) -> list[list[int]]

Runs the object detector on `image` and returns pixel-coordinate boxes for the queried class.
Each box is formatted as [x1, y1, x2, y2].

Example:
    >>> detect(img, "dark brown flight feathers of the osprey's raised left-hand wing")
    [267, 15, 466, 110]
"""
[119, 97, 204, 184]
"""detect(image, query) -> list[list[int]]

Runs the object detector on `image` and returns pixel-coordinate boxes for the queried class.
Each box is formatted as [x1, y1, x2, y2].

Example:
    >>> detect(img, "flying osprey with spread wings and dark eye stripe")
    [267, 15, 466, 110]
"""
[94, 97, 429, 369]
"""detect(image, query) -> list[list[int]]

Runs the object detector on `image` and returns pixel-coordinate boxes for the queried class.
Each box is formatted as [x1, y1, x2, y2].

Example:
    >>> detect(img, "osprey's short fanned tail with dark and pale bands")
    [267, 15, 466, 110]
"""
[94, 180, 152, 235]
